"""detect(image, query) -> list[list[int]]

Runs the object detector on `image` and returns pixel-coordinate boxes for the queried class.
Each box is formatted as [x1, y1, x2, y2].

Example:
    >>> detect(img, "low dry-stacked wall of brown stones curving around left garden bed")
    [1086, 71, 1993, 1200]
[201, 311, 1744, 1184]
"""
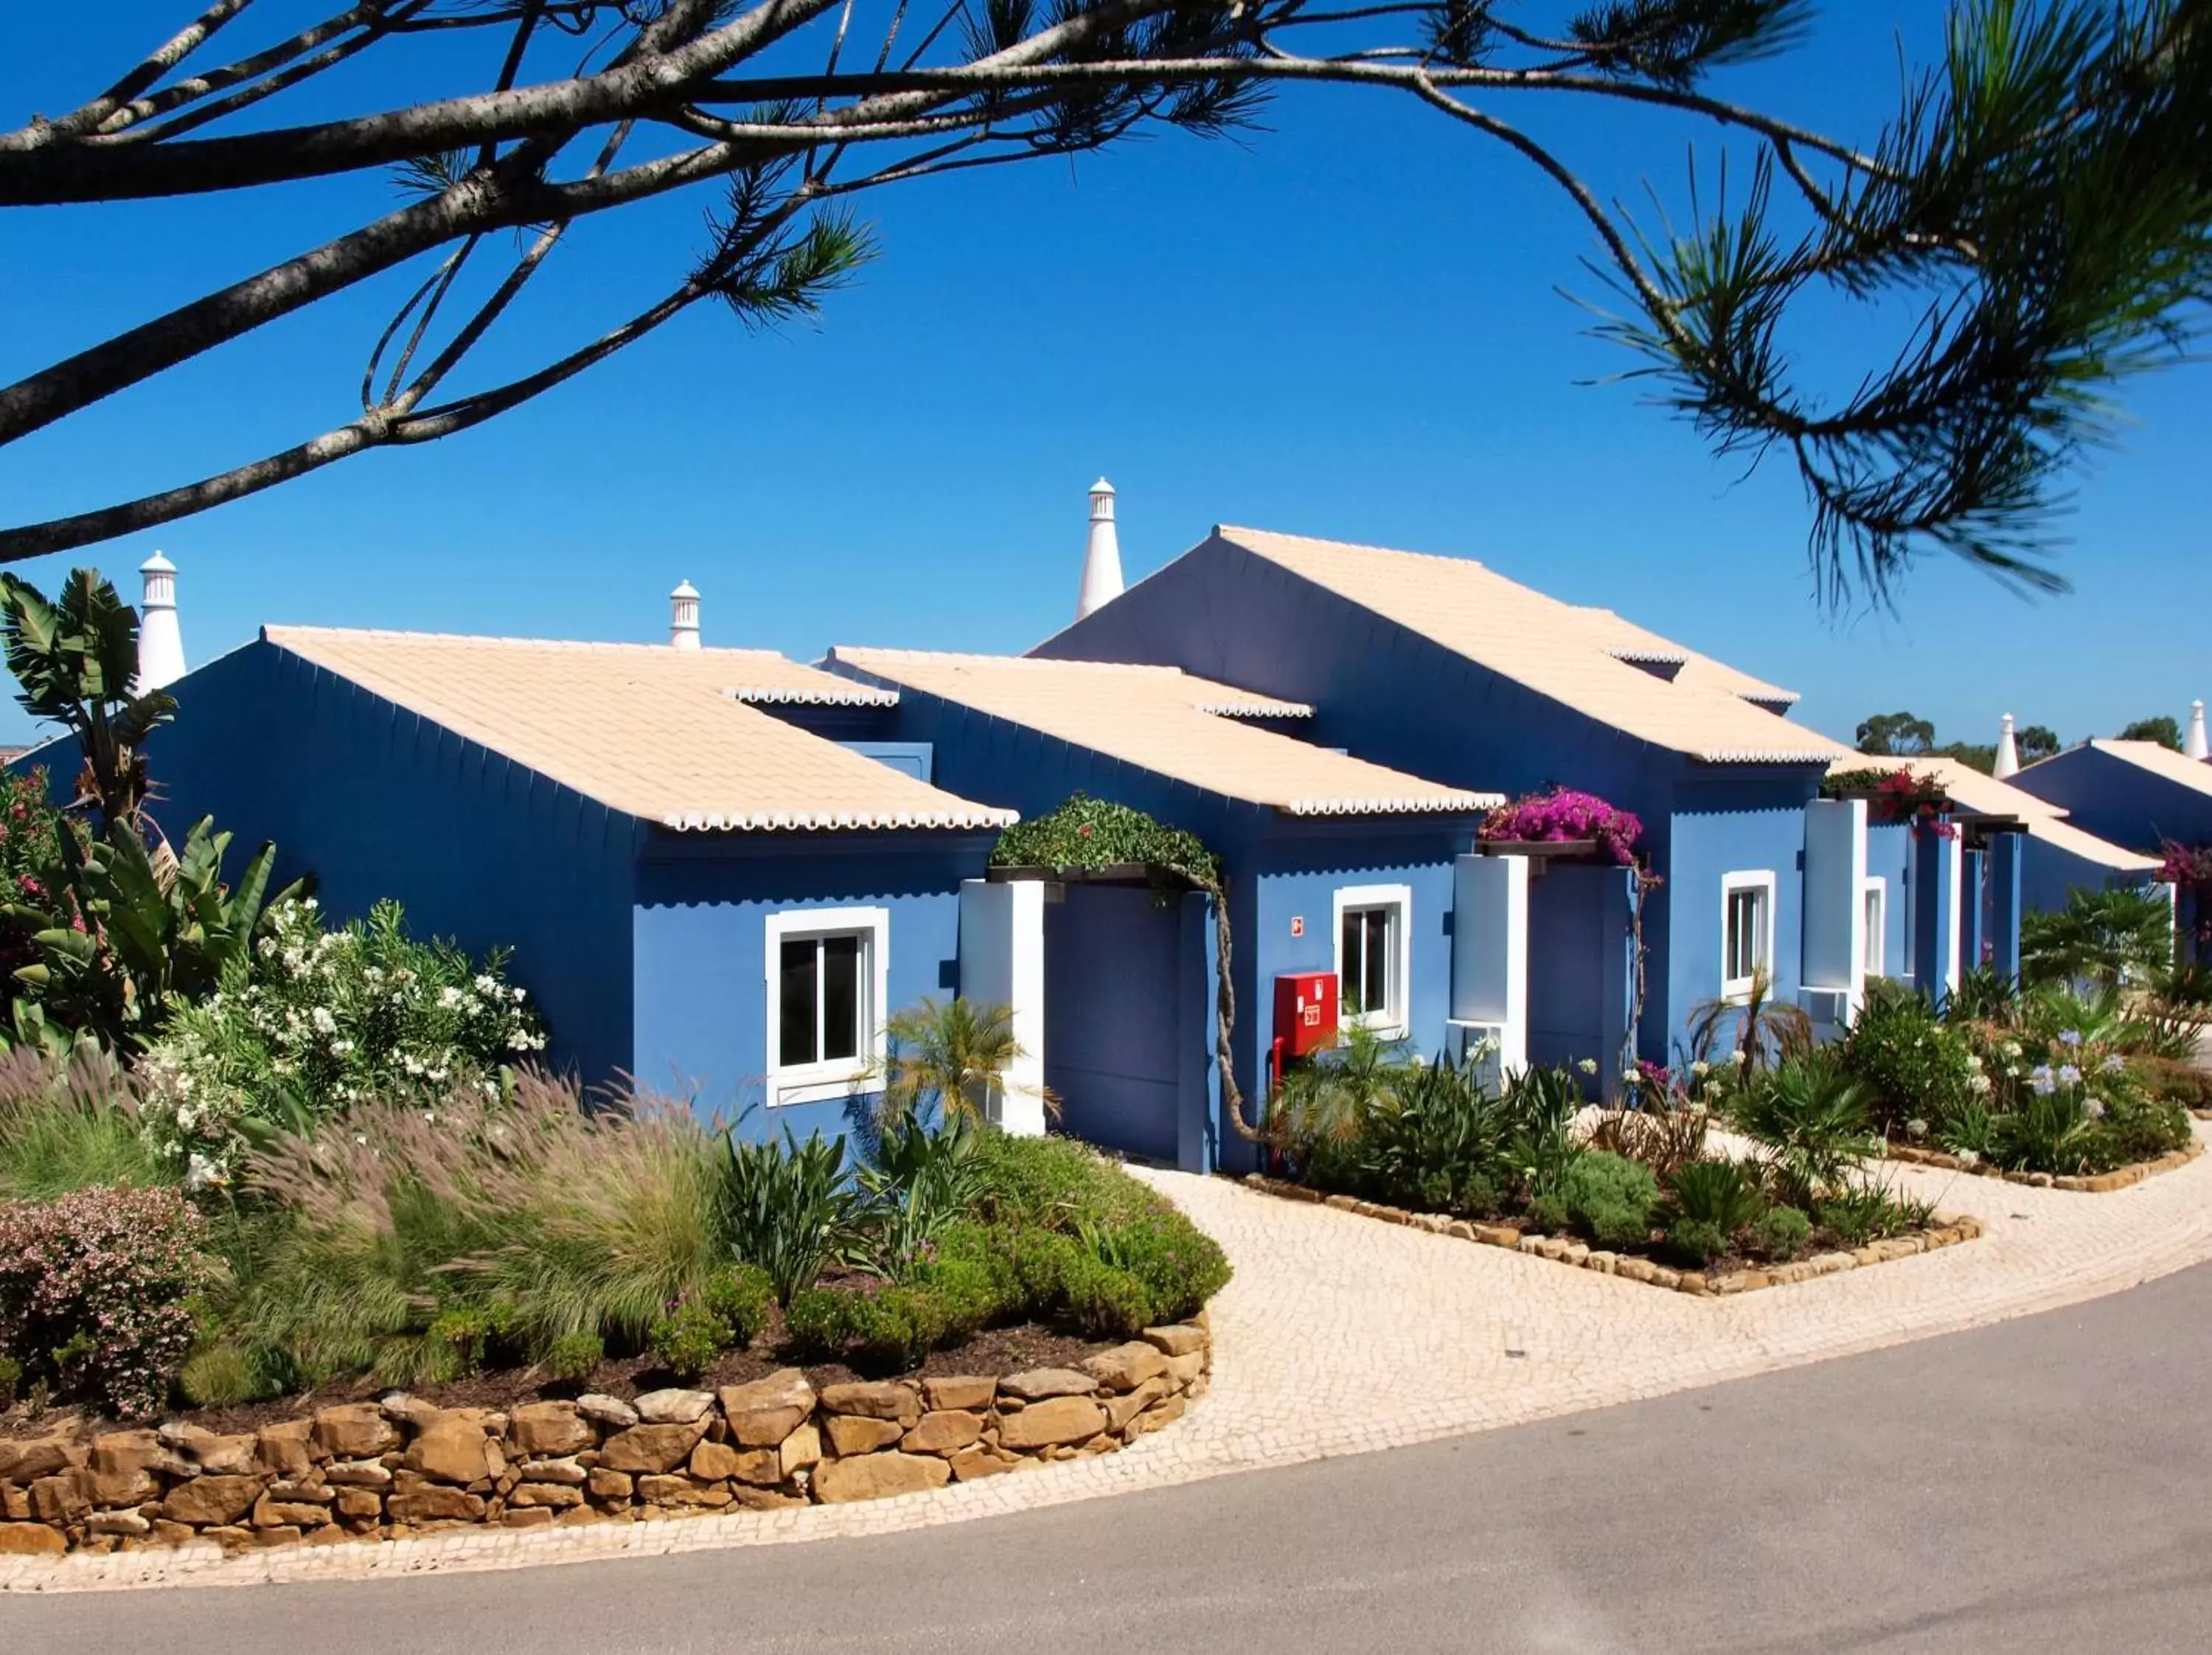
[0, 1316, 1212, 1555]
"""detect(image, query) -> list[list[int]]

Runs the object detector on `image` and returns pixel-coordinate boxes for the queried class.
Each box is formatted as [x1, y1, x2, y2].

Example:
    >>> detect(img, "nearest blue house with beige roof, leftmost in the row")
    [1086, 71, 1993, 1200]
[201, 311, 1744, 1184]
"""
[63, 626, 1042, 1137]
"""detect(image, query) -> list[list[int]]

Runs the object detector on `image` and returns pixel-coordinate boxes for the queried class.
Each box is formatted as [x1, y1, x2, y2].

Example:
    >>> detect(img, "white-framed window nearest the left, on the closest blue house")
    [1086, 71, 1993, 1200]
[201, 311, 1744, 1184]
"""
[768, 907, 889, 1104]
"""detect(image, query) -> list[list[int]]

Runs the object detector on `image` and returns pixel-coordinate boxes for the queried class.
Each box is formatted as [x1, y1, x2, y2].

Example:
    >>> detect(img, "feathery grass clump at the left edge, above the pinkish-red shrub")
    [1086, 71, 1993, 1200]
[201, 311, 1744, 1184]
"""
[0, 1049, 175, 1201]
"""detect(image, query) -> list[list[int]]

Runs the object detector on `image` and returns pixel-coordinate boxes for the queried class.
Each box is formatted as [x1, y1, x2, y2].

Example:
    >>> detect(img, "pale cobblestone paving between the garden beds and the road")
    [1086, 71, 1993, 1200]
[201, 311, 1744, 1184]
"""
[0, 1122, 2212, 1591]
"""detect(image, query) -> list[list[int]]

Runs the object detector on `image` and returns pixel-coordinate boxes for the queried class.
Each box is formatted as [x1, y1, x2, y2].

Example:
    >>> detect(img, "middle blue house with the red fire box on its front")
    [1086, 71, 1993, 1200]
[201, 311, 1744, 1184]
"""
[827, 648, 1513, 1168]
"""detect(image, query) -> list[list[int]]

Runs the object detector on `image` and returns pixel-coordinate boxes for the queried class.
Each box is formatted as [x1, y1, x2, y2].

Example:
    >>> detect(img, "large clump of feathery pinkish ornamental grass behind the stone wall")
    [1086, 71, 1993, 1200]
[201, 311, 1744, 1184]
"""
[237, 1075, 728, 1385]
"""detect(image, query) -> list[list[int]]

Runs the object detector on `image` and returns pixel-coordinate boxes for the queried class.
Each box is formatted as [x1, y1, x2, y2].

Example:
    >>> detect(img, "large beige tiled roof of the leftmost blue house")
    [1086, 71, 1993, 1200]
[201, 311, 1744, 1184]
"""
[261, 626, 1015, 830]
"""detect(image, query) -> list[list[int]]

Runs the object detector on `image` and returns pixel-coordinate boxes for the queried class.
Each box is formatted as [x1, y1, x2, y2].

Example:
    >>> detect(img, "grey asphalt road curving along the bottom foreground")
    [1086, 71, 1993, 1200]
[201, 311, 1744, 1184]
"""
[17, 1266, 2212, 1655]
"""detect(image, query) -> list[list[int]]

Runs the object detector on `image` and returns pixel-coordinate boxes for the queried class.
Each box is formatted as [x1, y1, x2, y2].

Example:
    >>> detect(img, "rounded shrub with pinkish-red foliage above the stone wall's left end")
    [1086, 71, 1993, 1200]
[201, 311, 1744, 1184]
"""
[0, 1184, 210, 1418]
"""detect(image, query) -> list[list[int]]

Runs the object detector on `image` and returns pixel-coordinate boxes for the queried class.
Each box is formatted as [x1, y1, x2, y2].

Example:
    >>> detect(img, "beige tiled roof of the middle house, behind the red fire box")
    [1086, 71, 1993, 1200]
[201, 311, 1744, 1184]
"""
[830, 648, 1500, 816]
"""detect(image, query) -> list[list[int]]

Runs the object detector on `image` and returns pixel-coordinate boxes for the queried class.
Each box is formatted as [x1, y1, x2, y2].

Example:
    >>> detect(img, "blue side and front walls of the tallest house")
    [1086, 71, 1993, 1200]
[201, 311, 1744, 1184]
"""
[1037, 540, 1832, 1060]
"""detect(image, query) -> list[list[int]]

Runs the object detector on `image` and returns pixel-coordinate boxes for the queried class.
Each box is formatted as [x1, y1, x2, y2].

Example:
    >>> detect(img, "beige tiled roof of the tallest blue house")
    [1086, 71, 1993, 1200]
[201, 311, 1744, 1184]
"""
[1214, 524, 1838, 763]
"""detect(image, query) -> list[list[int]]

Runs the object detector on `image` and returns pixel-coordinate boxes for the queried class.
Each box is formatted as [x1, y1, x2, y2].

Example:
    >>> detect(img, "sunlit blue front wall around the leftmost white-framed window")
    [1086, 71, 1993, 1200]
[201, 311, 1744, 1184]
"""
[624, 830, 991, 1137]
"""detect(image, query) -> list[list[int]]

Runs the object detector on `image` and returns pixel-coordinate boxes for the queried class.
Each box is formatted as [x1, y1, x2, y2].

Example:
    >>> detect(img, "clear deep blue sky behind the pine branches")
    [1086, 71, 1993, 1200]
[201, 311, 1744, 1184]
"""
[0, 0, 2212, 739]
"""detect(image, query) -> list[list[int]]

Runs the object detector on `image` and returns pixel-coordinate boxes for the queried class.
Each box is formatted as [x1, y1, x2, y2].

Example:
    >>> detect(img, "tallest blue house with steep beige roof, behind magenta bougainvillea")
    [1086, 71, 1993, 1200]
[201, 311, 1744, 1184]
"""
[1035, 527, 1858, 1062]
